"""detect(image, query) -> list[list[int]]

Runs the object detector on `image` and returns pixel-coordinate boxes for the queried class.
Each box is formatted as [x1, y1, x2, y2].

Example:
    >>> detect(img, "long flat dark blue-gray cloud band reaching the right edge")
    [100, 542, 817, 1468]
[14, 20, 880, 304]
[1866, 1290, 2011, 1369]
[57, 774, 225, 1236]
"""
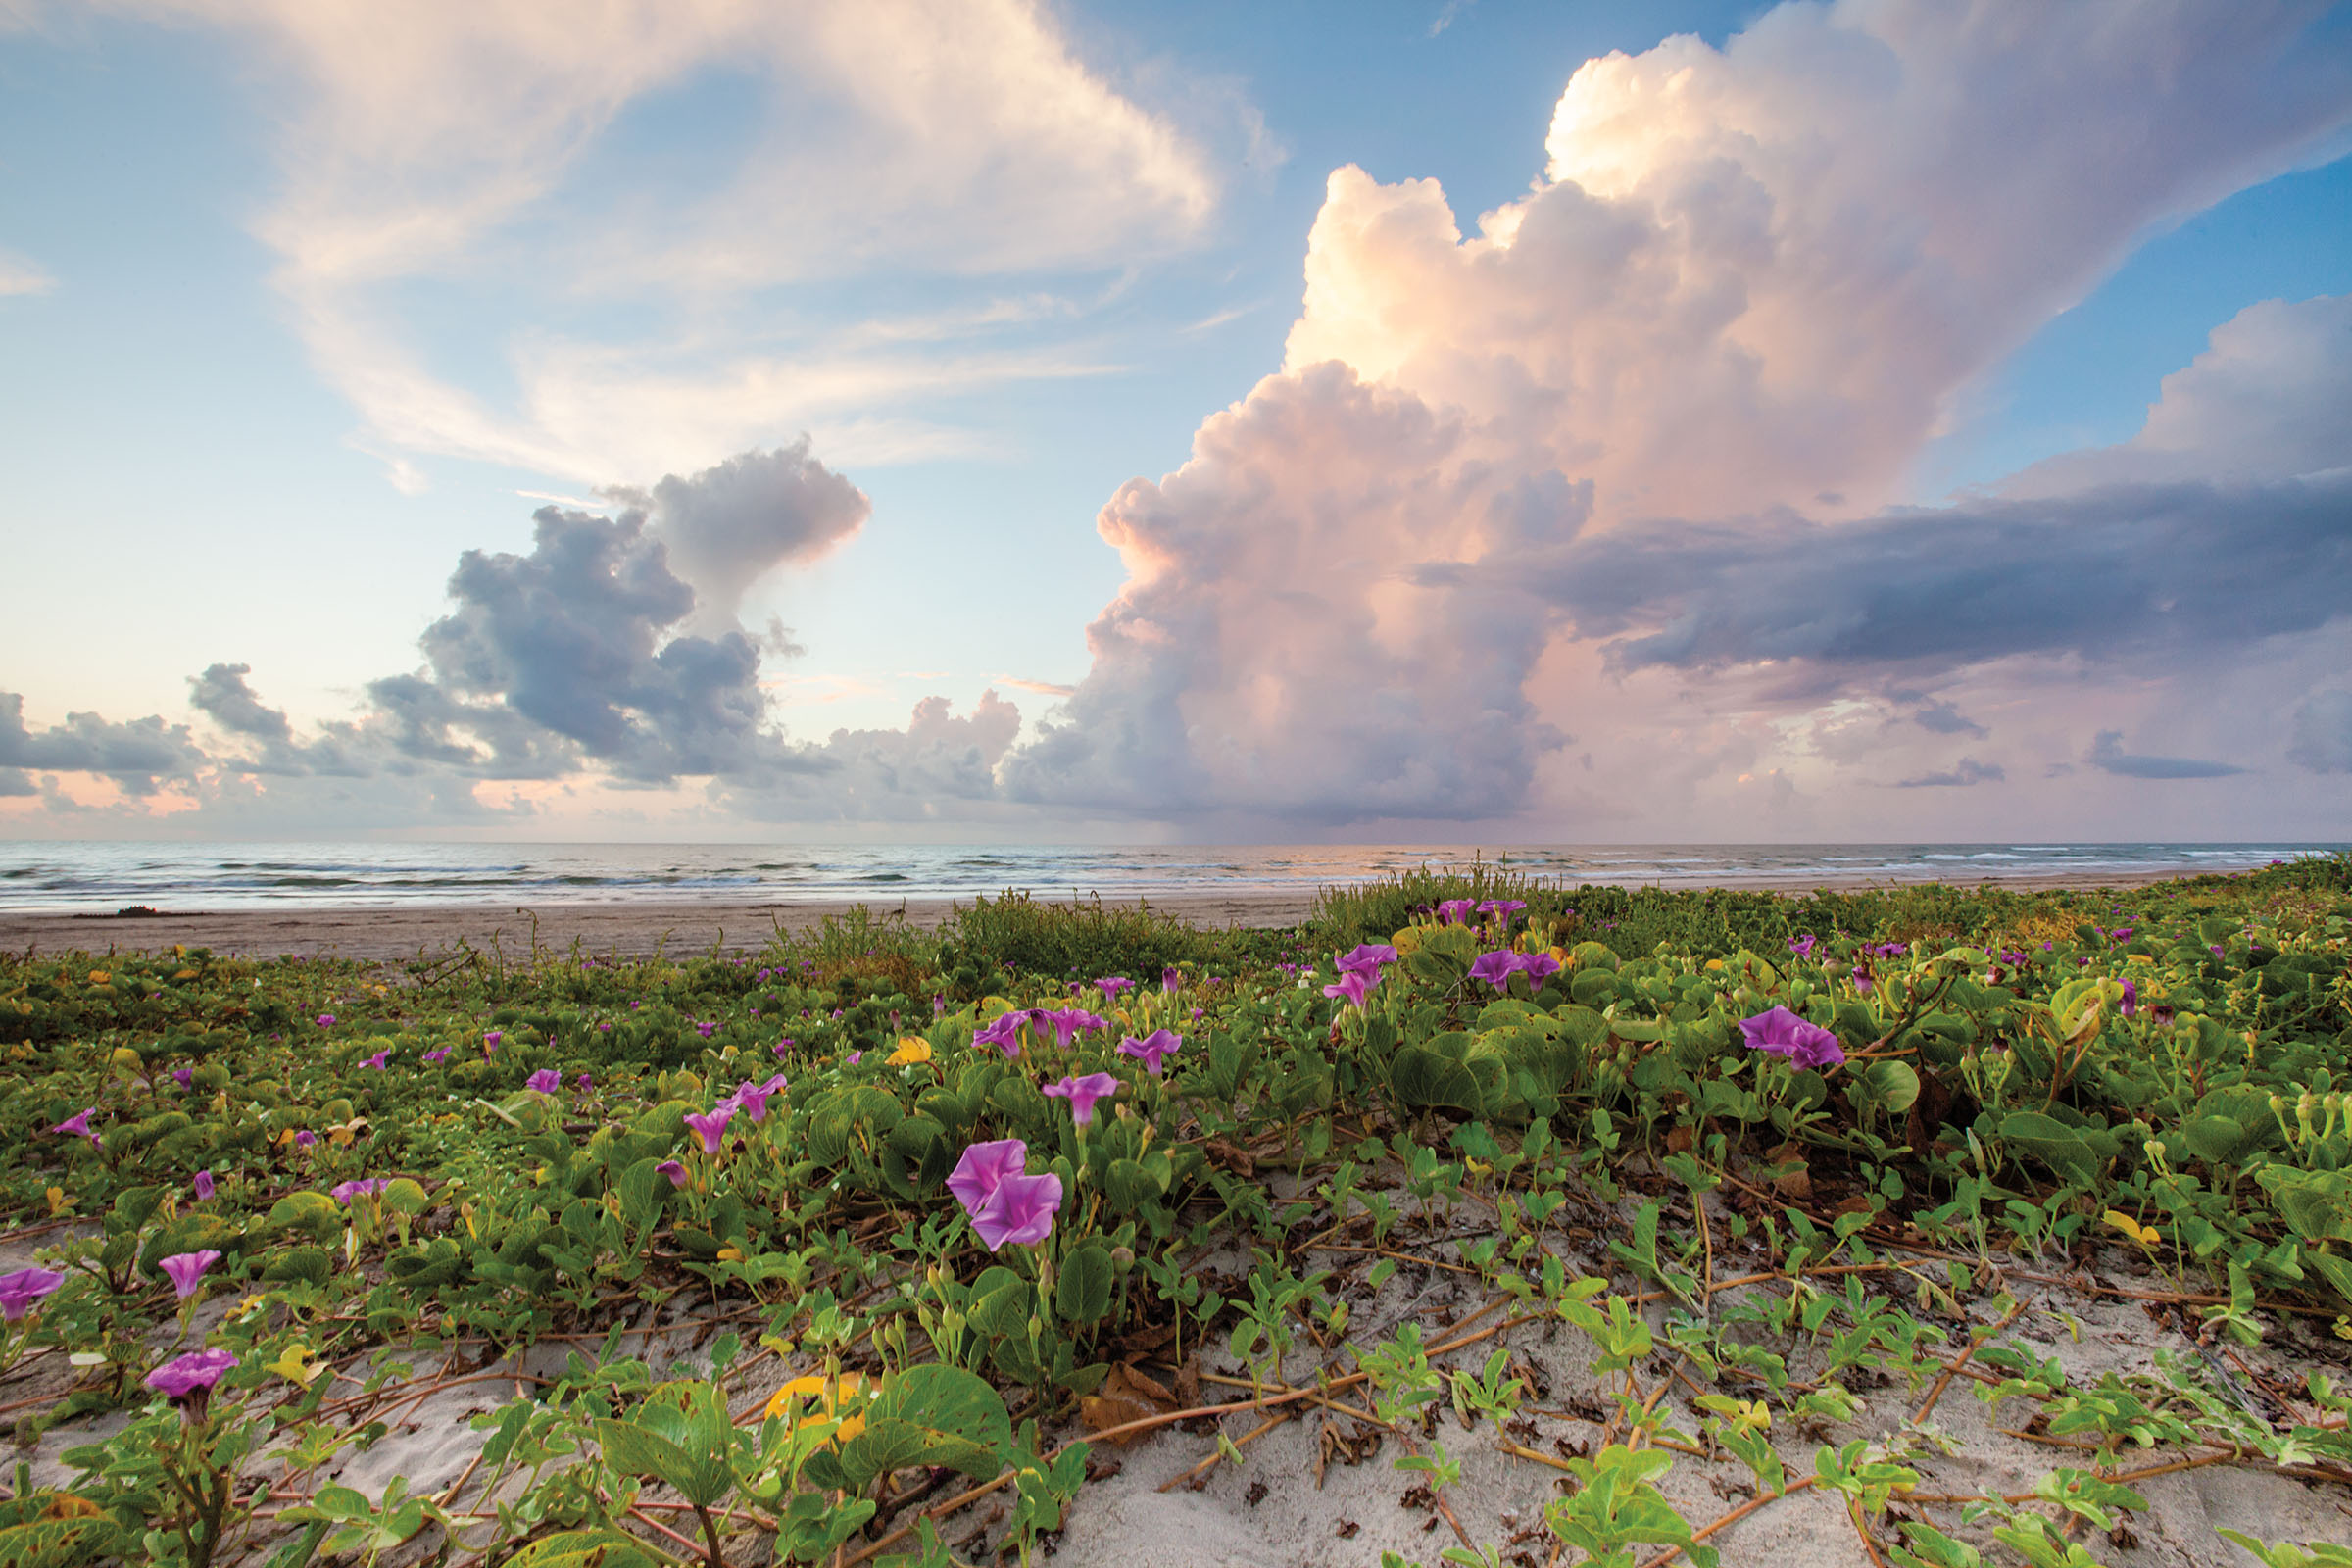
[1527, 470, 2352, 681]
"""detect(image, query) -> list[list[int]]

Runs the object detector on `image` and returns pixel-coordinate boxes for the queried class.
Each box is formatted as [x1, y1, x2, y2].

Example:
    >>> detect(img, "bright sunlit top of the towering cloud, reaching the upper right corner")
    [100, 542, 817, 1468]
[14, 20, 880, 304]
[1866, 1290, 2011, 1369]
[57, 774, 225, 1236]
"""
[1284, 0, 2352, 526]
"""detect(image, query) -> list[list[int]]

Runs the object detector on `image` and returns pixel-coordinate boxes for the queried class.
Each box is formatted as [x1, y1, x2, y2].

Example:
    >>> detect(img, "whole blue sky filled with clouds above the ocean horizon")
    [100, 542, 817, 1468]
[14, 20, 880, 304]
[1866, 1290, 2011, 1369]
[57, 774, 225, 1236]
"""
[0, 0, 2352, 842]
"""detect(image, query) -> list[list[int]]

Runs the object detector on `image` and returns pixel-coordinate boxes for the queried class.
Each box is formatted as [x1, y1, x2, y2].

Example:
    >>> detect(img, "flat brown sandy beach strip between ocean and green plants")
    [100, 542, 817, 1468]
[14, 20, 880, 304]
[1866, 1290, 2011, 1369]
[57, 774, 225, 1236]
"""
[0, 870, 2238, 961]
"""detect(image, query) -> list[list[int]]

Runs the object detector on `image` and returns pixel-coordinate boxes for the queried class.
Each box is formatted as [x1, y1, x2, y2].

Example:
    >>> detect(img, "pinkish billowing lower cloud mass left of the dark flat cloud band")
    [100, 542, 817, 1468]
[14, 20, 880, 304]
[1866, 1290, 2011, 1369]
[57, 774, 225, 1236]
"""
[1004, 365, 1590, 825]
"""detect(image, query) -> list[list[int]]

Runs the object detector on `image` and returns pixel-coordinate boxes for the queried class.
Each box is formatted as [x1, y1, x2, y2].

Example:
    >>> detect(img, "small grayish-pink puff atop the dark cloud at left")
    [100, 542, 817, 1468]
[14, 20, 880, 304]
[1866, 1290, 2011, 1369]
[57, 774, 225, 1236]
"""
[602, 437, 872, 630]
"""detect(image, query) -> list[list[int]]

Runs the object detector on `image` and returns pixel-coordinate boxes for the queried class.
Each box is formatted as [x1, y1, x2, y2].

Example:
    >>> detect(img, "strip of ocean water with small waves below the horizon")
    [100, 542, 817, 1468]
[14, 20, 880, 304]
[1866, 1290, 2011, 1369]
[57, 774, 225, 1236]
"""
[0, 842, 2347, 912]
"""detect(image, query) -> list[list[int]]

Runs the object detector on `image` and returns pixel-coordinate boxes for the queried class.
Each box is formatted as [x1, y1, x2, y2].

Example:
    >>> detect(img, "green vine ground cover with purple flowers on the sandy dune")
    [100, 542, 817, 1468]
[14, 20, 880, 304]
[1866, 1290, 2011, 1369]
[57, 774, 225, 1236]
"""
[0, 858, 2352, 1568]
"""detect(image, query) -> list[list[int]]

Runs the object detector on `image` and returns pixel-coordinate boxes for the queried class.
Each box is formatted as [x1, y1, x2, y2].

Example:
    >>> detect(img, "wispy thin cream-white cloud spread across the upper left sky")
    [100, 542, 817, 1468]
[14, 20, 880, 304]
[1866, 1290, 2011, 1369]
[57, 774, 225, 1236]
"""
[86, 0, 1249, 482]
